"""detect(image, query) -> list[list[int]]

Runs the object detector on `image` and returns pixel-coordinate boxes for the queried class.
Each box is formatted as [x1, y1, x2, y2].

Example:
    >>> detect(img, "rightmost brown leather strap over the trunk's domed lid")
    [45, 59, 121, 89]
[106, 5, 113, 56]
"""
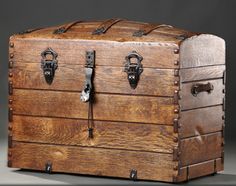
[133, 24, 173, 37]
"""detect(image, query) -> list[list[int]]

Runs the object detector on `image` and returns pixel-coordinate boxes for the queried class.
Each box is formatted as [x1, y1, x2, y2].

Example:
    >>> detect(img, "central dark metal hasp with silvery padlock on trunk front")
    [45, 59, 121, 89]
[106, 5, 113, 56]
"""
[80, 51, 95, 102]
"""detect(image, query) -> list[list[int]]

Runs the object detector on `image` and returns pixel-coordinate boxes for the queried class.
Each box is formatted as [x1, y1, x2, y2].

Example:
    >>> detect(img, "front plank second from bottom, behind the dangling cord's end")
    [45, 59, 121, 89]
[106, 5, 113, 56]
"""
[12, 116, 177, 153]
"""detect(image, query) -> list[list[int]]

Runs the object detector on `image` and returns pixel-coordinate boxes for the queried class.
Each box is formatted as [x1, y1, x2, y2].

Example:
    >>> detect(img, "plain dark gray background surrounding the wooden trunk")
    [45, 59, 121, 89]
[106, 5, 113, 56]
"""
[0, 0, 236, 183]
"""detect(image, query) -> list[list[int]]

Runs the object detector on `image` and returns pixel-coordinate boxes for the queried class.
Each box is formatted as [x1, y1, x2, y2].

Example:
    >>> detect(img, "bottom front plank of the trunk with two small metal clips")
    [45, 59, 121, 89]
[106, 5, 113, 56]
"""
[12, 142, 176, 181]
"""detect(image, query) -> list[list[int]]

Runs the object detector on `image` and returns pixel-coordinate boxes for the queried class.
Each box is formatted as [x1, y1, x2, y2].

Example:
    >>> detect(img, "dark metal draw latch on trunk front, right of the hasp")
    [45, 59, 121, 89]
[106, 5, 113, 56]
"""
[124, 51, 143, 89]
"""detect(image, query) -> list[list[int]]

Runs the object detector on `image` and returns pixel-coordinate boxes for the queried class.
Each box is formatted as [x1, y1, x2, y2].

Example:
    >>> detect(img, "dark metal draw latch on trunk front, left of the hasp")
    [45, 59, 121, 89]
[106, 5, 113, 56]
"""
[41, 48, 58, 85]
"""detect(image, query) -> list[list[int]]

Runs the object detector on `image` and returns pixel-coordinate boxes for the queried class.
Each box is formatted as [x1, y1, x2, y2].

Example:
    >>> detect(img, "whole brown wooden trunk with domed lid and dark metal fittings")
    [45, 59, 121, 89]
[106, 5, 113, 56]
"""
[8, 19, 225, 182]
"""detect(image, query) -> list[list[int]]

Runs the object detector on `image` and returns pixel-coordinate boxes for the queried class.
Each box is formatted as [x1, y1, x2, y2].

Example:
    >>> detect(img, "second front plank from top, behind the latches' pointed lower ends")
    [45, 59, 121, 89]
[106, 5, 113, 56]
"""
[13, 62, 175, 96]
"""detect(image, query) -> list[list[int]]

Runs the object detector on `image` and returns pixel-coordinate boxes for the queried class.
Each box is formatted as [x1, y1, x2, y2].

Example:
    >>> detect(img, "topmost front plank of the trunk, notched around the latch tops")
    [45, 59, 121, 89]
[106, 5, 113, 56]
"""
[12, 38, 178, 68]
